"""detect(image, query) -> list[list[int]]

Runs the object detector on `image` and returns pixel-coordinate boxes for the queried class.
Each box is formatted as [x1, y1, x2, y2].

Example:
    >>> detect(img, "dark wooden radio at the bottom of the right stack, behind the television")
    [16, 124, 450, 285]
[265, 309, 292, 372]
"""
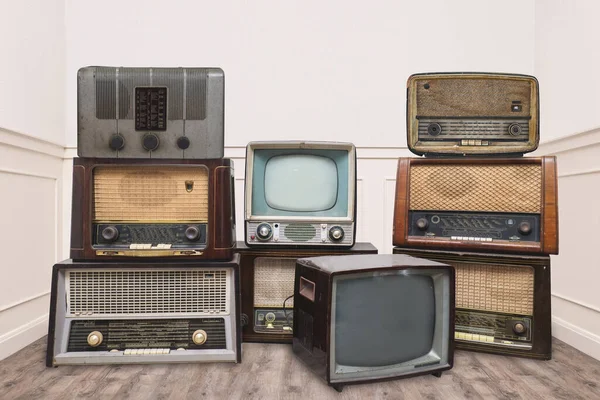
[393, 248, 552, 360]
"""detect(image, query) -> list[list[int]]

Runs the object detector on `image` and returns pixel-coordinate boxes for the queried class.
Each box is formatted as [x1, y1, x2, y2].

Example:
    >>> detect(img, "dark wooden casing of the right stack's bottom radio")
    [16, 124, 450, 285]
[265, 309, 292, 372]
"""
[393, 248, 552, 360]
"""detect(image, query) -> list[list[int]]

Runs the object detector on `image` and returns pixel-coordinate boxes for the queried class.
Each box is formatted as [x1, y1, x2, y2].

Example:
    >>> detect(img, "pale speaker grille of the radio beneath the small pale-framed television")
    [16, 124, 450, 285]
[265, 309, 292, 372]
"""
[254, 257, 296, 308]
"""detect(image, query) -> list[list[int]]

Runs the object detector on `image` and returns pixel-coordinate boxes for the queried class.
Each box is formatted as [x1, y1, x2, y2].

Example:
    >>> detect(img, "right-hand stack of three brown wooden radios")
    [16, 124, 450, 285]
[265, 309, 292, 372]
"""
[393, 73, 558, 359]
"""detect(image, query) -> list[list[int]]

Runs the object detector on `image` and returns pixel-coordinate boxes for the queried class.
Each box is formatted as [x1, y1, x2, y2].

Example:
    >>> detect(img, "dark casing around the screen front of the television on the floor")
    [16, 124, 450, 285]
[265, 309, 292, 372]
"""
[292, 260, 455, 392]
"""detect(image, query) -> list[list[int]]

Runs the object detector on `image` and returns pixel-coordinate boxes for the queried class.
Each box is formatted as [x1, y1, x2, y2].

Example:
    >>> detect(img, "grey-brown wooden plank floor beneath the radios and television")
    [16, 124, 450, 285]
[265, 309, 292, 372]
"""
[0, 338, 600, 400]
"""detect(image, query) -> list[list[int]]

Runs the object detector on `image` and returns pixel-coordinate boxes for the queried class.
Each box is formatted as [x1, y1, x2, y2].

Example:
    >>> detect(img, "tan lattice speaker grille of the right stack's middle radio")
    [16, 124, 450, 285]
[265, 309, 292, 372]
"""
[410, 164, 542, 213]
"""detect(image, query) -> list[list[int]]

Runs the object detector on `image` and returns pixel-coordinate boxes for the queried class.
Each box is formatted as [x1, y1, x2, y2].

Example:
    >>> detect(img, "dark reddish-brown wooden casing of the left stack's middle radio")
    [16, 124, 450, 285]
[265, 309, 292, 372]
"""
[71, 157, 235, 262]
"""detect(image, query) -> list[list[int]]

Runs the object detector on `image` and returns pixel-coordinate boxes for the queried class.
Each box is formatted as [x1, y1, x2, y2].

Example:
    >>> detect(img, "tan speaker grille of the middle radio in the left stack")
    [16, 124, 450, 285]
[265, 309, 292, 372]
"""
[94, 166, 208, 222]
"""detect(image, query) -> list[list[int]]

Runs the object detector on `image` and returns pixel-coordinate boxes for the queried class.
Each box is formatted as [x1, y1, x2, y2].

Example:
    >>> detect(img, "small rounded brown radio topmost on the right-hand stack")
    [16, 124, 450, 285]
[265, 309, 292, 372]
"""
[406, 73, 540, 155]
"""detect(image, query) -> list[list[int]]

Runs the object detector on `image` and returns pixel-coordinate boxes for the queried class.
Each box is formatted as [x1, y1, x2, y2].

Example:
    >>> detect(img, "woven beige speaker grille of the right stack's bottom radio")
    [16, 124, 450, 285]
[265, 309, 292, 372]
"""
[452, 262, 534, 315]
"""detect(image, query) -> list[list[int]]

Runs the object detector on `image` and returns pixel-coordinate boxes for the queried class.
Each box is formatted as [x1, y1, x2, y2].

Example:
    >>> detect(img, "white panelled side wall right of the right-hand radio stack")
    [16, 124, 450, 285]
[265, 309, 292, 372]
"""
[535, 0, 600, 359]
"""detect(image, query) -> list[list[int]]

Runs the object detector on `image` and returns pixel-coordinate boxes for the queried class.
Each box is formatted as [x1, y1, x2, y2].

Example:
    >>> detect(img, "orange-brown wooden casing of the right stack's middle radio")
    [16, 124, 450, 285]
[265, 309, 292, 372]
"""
[393, 156, 558, 254]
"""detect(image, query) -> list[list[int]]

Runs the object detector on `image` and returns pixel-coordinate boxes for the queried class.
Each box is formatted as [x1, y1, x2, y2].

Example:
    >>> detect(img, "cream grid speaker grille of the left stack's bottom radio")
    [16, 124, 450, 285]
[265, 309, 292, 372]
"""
[66, 268, 231, 316]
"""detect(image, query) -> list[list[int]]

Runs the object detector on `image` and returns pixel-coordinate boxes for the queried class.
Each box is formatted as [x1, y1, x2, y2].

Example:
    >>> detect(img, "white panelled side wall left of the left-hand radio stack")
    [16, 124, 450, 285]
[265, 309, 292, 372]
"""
[0, 0, 66, 359]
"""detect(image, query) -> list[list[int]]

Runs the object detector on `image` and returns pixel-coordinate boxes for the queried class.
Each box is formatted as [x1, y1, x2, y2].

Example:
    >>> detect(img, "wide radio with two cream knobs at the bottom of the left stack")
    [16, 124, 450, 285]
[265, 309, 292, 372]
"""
[46, 254, 241, 367]
